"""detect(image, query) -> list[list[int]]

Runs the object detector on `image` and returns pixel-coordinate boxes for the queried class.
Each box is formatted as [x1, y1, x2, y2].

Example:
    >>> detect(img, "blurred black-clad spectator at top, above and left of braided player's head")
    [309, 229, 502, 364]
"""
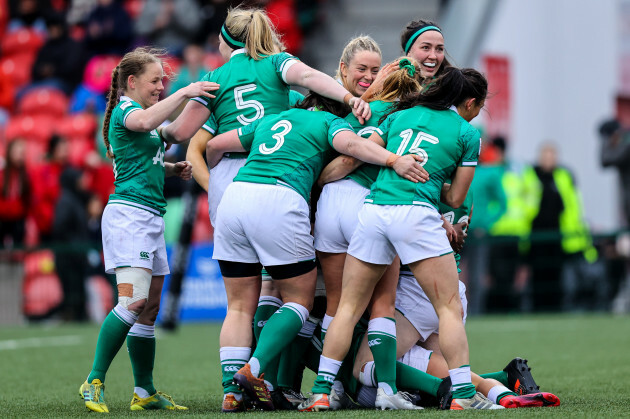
[85, 0, 133, 55]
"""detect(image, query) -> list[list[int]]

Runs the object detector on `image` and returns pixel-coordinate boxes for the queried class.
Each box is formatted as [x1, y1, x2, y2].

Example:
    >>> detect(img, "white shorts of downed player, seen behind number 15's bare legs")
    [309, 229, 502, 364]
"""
[396, 275, 468, 341]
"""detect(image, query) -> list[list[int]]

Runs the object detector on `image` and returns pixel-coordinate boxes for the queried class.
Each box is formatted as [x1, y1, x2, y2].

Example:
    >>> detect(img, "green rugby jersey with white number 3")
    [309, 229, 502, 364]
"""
[234, 109, 352, 201]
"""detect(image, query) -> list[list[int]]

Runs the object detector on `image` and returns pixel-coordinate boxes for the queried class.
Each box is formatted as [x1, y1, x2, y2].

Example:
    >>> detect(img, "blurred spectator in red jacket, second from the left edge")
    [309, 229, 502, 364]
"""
[30, 135, 69, 244]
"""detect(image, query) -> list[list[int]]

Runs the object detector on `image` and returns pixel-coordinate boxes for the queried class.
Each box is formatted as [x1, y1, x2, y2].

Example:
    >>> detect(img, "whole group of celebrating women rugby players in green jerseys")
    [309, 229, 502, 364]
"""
[79, 4, 560, 413]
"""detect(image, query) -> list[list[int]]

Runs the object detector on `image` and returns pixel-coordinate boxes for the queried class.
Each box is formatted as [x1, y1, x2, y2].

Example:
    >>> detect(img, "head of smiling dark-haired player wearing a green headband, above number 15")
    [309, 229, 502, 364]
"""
[400, 19, 451, 78]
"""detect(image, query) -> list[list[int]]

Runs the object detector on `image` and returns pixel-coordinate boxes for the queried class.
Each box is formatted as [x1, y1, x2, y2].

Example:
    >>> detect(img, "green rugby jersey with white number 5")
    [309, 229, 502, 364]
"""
[192, 49, 298, 158]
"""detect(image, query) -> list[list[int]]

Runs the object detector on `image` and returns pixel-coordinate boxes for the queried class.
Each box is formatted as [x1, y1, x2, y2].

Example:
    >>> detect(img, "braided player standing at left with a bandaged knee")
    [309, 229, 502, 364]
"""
[79, 48, 219, 413]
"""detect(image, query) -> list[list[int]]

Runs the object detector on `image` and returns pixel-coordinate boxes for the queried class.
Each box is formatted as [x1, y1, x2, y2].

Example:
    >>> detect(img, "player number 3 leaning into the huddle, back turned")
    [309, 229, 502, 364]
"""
[207, 93, 425, 410]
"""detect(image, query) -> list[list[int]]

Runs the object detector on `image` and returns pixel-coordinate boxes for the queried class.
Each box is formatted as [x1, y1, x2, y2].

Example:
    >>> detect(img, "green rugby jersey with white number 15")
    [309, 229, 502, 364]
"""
[365, 106, 481, 210]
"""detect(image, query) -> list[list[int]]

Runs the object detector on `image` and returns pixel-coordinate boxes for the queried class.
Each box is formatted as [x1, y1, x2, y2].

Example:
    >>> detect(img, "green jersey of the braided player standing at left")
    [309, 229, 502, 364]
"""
[108, 96, 166, 215]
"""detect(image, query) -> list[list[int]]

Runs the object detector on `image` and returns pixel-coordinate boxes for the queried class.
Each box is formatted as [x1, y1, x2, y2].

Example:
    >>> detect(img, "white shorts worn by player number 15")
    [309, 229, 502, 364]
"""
[348, 203, 453, 265]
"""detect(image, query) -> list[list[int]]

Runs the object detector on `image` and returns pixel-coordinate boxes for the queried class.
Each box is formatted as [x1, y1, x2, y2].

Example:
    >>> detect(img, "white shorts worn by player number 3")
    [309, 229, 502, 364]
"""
[212, 182, 315, 266]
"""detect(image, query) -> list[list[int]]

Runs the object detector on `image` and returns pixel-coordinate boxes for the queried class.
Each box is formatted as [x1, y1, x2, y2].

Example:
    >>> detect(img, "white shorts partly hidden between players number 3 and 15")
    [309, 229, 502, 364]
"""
[315, 179, 370, 253]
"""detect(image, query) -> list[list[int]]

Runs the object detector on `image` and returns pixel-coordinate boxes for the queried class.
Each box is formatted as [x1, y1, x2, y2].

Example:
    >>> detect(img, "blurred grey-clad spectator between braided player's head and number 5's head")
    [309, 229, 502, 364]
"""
[135, 0, 201, 55]
